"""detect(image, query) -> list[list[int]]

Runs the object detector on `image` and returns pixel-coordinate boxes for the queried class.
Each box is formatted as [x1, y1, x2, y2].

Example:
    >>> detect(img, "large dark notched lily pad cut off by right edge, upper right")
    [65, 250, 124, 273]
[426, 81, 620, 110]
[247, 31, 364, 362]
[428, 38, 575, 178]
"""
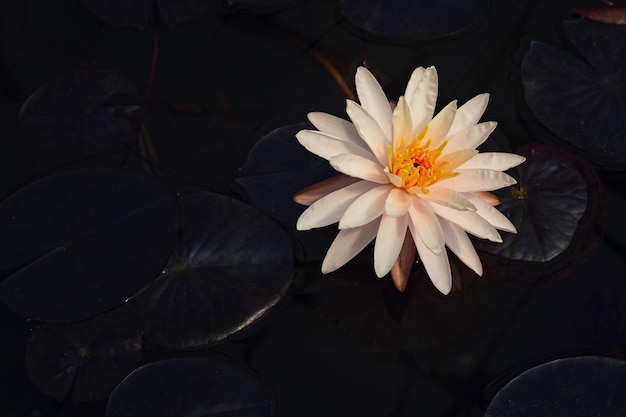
[521, 18, 626, 169]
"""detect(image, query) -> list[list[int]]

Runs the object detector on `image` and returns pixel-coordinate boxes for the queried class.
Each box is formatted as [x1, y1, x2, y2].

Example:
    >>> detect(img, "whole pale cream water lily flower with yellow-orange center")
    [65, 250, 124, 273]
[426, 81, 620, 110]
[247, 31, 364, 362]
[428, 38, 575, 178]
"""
[295, 67, 525, 294]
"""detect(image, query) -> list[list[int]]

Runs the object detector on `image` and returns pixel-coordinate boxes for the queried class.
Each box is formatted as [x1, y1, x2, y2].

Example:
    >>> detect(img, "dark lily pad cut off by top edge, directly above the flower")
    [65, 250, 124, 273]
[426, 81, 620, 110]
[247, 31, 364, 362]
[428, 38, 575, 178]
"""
[341, 0, 486, 41]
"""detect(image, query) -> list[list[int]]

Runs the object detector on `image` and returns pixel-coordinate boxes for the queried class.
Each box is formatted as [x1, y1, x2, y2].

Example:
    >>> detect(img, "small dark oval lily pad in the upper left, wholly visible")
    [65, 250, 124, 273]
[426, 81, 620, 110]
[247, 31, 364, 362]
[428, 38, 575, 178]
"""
[19, 70, 144, 156]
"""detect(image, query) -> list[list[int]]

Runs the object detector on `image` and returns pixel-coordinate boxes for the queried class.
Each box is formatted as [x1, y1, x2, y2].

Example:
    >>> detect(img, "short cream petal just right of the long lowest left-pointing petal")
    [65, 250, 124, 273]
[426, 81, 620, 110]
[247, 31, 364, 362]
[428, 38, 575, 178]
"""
[339, 185, 391, 229]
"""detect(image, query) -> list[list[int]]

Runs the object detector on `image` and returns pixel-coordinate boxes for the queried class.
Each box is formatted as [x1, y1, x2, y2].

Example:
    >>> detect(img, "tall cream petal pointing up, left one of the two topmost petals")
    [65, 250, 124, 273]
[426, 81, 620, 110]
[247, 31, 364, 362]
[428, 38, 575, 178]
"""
[355, 67, 391, 141]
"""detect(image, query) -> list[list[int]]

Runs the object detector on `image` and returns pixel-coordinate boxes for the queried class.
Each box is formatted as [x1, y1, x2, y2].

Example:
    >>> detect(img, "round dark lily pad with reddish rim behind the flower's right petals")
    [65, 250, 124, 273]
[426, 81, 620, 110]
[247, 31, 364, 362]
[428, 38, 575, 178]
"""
[475, 145, 604, 281]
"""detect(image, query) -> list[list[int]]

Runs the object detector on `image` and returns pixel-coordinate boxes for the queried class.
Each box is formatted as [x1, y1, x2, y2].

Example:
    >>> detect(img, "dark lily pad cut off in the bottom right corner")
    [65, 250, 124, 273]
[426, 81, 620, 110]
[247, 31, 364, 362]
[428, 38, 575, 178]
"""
[485, 356, 626, 417]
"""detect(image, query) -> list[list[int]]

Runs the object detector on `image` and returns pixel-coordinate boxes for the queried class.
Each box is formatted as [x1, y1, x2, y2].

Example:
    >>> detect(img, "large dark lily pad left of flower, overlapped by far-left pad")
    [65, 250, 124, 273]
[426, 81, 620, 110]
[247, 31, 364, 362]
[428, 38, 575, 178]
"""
[131, 193, 294, 349]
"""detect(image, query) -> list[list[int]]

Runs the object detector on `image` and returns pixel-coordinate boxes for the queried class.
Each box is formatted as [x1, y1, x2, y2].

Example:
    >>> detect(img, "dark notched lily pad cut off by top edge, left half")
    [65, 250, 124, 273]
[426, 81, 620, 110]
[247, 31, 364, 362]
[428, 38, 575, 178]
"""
[80, 0, 218, 29]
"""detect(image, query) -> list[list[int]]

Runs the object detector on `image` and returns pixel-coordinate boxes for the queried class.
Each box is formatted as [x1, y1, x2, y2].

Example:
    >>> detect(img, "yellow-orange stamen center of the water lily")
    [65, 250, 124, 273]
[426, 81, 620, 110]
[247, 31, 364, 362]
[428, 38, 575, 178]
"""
[387, 125, 458, 194]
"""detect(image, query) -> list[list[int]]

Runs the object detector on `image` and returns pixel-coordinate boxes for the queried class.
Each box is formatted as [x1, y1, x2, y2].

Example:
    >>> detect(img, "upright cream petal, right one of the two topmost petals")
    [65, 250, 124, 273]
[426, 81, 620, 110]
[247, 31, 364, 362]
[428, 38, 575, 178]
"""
[406, 67, 438, 137]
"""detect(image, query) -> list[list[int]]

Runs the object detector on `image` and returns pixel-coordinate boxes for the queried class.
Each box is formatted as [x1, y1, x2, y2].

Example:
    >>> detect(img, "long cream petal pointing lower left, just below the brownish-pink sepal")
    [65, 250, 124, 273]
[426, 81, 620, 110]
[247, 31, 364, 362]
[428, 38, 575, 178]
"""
[296, 181, 376, 230]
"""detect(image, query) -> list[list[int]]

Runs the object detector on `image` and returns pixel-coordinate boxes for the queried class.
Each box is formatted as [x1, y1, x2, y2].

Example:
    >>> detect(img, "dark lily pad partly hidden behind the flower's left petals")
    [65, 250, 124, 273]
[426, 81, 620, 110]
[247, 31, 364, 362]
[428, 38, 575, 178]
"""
[237, 123, 337, 227]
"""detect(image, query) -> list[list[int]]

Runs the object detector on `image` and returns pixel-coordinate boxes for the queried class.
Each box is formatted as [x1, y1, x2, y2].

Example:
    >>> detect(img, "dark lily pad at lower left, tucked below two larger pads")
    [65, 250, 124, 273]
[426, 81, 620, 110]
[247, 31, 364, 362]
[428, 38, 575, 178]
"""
[26, 308, 142, 403]
